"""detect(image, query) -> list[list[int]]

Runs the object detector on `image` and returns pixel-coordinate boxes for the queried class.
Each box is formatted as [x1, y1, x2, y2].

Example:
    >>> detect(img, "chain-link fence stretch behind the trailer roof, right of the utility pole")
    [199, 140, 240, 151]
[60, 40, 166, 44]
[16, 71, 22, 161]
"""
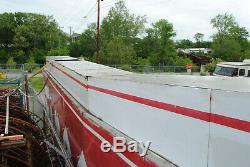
[108, 65, 201, 73]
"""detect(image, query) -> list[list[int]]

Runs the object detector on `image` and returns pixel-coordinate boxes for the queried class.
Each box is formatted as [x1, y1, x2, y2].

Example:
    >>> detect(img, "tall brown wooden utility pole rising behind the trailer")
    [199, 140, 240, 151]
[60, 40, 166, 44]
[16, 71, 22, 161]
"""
[96, 0, 103, 64]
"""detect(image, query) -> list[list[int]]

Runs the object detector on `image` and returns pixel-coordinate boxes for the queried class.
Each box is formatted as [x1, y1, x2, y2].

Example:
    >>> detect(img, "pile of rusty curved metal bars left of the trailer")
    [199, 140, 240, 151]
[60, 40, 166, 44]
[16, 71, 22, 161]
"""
[0, 88, 60, 167]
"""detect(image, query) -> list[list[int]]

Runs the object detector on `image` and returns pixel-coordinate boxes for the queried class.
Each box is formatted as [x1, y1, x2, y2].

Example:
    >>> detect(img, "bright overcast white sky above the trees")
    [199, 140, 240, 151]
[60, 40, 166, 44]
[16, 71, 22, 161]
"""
[0, 0, 250, 40]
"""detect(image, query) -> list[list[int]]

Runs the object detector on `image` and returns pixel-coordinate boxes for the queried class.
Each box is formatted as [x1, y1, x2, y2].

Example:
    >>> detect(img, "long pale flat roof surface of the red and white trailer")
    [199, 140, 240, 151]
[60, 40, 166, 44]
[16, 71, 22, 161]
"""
[48, 56, 250, 92]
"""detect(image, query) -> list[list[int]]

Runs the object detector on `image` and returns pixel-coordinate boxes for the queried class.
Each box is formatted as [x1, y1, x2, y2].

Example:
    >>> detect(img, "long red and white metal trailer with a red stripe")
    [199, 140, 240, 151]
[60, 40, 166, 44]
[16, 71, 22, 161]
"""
[45, 57, 250, 167]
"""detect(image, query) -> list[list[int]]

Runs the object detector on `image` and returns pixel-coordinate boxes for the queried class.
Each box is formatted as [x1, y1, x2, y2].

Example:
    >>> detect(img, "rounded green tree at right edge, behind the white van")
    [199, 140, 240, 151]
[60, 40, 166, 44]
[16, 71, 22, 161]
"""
[211, 13, 248, 61]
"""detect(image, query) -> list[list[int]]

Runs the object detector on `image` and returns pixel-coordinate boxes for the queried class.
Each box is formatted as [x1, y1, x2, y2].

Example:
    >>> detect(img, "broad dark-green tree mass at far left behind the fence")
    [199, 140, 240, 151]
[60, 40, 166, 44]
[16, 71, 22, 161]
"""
[0, 12, 67, 63]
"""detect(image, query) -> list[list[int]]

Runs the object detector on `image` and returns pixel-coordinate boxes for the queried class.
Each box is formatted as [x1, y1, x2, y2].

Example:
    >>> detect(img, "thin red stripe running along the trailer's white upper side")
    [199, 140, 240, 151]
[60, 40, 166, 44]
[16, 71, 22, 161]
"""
[51, 64, 250, 133]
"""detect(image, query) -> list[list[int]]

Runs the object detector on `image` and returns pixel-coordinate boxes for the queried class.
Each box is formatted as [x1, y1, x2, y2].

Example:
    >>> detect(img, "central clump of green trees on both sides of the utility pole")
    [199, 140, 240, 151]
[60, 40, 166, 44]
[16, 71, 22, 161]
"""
[70, 0, 193, 67]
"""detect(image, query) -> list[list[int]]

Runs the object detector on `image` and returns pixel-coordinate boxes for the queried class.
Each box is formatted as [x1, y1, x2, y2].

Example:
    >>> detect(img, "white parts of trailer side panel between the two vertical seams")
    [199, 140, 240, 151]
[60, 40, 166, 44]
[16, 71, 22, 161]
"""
[89, 78, 210, 167]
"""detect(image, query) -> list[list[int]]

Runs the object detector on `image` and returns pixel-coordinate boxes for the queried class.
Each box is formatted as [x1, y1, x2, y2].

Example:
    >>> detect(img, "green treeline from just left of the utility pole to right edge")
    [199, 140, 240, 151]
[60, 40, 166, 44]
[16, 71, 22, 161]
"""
[70, 1, 250, 65]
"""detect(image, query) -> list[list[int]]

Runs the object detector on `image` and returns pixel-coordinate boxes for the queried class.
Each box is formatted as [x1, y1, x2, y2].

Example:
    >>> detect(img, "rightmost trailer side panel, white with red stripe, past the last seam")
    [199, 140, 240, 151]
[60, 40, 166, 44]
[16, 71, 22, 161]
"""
[208, 90, 250, 167]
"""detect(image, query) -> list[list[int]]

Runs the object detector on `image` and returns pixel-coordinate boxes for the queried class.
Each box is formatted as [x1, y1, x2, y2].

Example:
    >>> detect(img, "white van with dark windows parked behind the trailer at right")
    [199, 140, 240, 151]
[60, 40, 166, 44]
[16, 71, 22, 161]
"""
[213, 59, 250, 77]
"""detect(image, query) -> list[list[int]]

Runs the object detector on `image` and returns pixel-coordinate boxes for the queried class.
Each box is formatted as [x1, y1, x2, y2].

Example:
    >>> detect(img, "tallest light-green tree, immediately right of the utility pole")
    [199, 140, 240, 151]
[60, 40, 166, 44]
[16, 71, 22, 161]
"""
[101, 0, 146, 64]
